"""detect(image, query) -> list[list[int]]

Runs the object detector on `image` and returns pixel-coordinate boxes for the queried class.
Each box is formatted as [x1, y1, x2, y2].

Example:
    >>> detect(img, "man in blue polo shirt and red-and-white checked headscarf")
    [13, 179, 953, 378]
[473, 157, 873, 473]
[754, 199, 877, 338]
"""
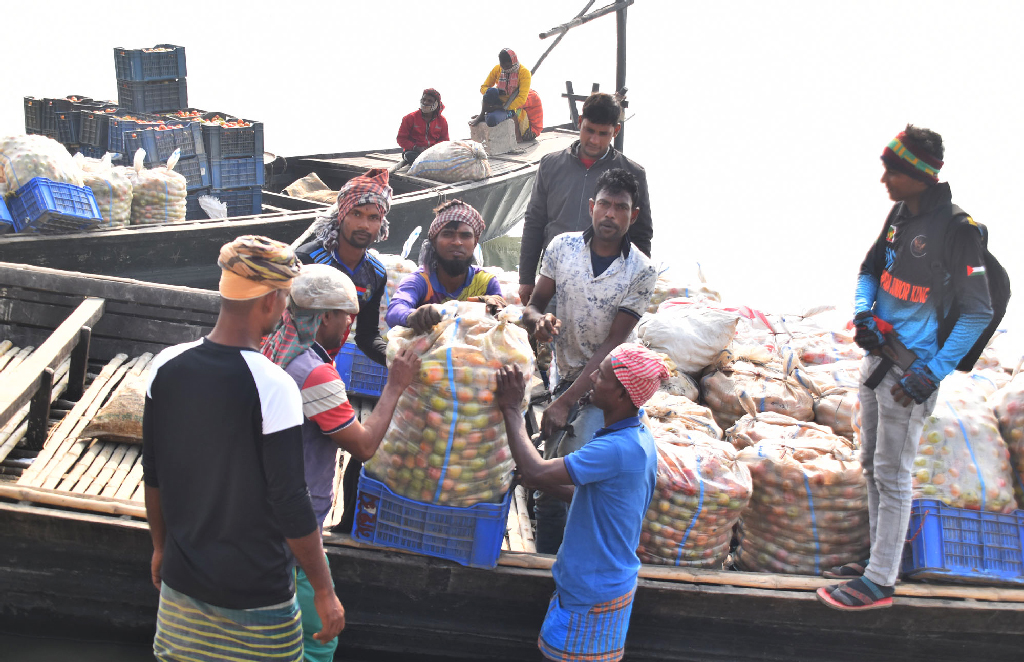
[498, 343, 669, 662]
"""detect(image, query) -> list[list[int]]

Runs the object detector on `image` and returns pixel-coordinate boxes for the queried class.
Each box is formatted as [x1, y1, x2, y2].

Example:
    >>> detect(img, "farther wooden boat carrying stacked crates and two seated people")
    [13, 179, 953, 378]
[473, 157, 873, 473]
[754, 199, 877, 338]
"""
[0, 127, 575, 288]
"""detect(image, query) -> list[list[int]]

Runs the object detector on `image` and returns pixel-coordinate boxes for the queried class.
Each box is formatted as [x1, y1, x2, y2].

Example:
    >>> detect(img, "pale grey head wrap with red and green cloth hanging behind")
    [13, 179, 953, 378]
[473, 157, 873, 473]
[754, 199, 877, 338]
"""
[260, 264, 359, 368]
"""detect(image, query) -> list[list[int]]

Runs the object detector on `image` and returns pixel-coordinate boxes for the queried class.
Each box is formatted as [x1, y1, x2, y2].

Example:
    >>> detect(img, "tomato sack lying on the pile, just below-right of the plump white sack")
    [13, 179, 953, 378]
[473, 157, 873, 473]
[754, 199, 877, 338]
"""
[700, 361, 814, 427]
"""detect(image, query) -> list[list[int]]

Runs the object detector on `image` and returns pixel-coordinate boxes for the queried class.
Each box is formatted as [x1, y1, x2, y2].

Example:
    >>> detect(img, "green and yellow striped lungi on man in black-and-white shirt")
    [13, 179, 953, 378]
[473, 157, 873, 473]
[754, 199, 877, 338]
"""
[153, 584, 302, 662]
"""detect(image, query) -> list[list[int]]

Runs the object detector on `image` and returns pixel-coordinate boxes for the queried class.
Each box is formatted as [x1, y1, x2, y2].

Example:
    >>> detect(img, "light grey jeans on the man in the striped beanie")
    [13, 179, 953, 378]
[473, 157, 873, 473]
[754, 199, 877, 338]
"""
[860, 356, 938, 586]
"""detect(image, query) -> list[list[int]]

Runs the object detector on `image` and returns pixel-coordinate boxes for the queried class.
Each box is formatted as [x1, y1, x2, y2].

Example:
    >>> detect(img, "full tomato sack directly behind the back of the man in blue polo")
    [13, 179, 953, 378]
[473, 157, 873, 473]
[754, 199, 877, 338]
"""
[637, 432, 751, 569]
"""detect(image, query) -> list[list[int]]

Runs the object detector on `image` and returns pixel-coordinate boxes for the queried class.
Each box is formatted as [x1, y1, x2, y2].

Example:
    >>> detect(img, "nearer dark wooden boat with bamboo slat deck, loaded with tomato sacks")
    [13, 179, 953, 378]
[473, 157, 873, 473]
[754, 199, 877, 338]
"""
[0, 263, 1024, 661]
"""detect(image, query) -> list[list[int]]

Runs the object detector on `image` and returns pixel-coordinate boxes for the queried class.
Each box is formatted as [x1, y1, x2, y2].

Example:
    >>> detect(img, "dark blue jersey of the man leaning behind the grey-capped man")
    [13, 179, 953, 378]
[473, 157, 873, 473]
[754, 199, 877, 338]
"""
[295, 240, 387, 366]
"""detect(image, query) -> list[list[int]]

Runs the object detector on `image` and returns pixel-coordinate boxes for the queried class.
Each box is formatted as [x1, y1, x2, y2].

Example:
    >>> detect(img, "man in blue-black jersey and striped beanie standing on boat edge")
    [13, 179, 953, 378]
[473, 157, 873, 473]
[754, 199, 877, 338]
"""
[818, 125, 992, 611]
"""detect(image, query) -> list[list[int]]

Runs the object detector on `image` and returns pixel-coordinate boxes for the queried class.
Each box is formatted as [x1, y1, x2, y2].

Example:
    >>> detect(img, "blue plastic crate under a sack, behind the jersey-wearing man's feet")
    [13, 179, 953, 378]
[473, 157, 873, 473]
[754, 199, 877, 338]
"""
[903, 499, 1024, 584]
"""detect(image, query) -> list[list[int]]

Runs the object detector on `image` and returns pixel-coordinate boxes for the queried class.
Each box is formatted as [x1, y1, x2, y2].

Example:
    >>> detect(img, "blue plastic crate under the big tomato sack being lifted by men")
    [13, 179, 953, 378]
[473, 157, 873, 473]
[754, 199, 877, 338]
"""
[352, 469, 512, 568]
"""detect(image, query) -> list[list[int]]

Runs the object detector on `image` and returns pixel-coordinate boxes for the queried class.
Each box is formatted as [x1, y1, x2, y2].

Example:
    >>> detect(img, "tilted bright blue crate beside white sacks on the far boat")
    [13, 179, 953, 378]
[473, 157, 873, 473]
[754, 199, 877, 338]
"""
[9, 177, 103, 234]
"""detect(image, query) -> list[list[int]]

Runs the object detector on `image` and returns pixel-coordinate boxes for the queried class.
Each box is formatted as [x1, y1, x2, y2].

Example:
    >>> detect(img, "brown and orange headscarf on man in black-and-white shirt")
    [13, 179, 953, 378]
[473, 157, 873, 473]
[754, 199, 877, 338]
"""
[217, 235, 301, 301]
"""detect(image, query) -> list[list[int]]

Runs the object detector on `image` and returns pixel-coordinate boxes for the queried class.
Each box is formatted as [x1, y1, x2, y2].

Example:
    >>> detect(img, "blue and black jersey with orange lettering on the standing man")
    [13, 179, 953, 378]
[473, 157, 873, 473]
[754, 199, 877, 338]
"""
[855, 183, 992, 379]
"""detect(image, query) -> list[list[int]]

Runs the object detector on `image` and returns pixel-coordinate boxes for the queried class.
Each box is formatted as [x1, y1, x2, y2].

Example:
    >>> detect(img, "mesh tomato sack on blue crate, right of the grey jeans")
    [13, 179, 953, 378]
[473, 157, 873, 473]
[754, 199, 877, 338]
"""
[912, 374, 1017, 512]
